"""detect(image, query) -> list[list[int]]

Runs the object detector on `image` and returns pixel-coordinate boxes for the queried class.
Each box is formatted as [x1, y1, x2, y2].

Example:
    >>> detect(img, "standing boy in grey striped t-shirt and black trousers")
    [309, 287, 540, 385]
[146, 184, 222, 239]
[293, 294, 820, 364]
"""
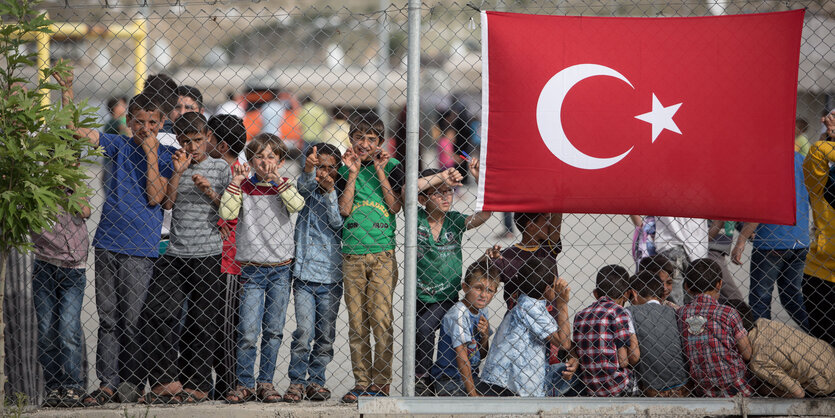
[144, 112, 231, 404]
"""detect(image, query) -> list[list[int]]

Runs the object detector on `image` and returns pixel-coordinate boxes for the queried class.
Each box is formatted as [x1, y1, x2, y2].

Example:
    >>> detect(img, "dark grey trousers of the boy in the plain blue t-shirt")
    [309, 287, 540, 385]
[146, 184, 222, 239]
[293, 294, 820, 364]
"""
[95, 248, 155, 390]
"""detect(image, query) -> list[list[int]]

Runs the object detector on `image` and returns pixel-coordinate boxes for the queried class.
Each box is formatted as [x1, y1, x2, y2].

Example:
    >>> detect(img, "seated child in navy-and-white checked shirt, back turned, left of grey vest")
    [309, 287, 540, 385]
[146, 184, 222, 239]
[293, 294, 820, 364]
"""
[574, 265, 641, 396]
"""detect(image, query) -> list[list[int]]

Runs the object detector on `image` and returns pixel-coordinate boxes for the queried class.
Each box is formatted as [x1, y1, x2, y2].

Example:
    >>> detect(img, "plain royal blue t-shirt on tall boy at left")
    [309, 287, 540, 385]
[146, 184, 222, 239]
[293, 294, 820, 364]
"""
[93, 133, 174, 258]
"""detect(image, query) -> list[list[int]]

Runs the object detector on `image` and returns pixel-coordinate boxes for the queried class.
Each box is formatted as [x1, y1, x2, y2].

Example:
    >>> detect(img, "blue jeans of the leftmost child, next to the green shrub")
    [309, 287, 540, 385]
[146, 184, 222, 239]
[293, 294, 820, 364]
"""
[32, 260, 87, 390]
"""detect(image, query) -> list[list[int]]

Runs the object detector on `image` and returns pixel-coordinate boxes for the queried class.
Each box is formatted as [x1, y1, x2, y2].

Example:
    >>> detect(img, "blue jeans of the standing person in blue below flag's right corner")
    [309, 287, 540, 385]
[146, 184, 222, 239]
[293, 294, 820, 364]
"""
[748, 248, 809, 330]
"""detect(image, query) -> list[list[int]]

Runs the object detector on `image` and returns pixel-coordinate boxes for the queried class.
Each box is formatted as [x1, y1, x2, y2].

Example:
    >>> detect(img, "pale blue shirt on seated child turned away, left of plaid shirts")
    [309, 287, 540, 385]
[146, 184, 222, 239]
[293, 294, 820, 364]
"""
[481, 294, 559, 396]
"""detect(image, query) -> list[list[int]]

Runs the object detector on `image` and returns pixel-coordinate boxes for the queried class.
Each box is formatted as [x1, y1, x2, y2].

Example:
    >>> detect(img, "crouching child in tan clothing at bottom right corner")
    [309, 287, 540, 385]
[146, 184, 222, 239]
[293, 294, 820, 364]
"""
[728, 299, 835, 398]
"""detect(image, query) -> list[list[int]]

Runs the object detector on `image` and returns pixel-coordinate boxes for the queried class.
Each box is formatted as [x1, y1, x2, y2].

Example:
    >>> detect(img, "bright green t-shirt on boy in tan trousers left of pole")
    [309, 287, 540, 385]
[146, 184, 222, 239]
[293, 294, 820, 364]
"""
[339, 158, 403, 254]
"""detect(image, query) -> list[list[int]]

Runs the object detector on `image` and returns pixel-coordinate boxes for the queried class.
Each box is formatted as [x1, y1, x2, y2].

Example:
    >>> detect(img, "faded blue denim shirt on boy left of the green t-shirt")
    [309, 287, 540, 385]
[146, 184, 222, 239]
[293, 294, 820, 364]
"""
[293, 171, 342, 284]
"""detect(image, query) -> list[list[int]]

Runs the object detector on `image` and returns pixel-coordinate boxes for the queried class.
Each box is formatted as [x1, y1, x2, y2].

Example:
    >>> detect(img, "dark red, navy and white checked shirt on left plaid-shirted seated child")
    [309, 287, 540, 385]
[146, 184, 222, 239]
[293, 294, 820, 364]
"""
[574, 296, 631, 396]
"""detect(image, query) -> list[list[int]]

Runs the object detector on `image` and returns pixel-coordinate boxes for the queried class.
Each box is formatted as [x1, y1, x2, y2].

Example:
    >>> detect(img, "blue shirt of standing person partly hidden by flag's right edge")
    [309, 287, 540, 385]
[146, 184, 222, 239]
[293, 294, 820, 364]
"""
[754, 152, 809, 250]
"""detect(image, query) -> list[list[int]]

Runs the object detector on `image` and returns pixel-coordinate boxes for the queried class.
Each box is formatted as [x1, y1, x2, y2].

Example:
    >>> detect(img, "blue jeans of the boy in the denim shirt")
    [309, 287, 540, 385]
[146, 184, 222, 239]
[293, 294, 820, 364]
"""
[287, 279, 342, 386]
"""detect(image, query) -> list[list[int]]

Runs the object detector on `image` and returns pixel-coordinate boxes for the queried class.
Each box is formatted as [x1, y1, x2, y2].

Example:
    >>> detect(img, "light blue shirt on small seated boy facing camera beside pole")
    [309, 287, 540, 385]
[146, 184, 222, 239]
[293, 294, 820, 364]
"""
[432, 302, 487, 379]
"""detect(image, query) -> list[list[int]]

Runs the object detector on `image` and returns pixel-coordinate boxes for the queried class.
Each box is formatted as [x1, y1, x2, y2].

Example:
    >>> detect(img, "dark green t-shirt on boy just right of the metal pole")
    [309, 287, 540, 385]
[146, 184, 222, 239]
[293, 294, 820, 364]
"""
[417, 208, 467, 303]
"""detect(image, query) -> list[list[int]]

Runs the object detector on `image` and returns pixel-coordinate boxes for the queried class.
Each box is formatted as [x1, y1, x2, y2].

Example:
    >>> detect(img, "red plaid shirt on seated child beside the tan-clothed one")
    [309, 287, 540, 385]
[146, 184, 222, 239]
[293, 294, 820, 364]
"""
[678, 294, 752, 397]
